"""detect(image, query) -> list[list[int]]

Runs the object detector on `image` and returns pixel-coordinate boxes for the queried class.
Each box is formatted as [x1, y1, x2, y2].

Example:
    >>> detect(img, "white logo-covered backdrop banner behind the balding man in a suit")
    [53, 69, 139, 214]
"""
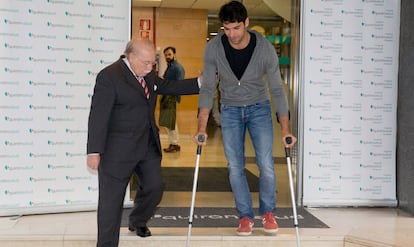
[0, 0, 131, 216]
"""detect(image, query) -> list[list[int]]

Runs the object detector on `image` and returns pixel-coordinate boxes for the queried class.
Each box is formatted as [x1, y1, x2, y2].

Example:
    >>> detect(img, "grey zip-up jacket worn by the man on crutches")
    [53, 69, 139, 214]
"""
[198, 31, 289, 116]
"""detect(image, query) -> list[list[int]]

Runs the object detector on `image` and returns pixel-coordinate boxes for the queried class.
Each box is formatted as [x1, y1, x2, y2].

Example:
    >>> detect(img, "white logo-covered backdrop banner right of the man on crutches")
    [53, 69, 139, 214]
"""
[301, 0, 400, 206]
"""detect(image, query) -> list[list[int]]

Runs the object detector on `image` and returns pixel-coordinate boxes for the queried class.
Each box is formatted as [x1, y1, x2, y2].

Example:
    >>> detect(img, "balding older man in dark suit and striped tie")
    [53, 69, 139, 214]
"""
[86, 38, 199, 247]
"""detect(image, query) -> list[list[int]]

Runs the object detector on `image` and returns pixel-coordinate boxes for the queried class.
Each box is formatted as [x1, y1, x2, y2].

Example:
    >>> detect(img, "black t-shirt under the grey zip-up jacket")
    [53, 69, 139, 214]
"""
[221, 32, 256, 80]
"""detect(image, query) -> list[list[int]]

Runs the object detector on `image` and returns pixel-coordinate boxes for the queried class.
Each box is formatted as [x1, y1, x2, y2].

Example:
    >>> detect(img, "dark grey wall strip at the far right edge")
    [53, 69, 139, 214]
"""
[397, 0, 414, 215]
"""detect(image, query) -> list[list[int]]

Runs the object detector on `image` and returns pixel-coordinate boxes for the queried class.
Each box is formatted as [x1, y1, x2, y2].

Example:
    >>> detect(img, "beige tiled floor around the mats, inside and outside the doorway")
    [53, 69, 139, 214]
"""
[0, 113, 414, 247]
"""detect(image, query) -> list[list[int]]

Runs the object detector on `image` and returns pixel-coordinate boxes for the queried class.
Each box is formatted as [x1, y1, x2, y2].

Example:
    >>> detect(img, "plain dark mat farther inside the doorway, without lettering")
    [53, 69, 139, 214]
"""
[131, 167, 259, 192]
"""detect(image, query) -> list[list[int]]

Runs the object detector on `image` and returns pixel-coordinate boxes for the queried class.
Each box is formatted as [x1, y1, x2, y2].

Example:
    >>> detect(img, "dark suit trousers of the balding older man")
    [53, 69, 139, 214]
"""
[97, 130, 164, 247]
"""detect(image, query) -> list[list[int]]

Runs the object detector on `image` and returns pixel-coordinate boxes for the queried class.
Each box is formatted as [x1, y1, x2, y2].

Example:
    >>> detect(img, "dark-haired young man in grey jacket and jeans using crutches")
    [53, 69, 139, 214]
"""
[194, 1, 296, 235]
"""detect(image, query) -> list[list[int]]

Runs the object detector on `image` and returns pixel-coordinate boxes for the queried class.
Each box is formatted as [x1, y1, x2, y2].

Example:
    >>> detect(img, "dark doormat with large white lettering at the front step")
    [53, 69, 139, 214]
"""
[121, 207, 329, 228]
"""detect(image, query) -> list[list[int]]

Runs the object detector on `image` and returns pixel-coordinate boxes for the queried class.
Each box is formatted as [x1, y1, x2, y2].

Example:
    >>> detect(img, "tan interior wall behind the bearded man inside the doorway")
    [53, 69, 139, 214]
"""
[131, 8, 207, 111]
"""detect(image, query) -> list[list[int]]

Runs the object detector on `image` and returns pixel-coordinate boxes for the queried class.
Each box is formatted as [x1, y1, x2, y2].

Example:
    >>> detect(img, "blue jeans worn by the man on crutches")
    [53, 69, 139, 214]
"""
[221, 100, 276, 219]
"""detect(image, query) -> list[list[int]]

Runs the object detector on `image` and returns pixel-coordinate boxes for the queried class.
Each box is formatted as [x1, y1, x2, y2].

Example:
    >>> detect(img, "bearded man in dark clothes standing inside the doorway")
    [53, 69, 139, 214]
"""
[158, 46, 185, 153]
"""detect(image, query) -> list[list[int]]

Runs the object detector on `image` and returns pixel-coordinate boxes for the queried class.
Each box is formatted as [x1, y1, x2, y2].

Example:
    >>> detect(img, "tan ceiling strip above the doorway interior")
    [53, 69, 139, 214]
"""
[132, 0, 278, 17]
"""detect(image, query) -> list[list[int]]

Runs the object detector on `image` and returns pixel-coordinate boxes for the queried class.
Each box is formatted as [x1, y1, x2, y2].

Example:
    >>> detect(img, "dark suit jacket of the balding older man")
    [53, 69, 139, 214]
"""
[87, 59, 199, 172]
